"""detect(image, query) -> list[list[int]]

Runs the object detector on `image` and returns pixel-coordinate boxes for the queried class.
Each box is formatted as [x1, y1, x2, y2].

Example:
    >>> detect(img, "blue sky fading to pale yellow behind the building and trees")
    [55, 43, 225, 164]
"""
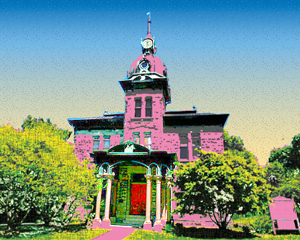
[0, 0, 300, 164]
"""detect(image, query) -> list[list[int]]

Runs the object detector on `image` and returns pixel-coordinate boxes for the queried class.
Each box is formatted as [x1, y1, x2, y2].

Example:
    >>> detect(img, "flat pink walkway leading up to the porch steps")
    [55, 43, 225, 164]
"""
[92, 225, 138, 240]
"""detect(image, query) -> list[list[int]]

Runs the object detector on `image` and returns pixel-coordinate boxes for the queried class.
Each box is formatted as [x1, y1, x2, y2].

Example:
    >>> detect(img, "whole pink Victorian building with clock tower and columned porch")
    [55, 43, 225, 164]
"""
[68, 15, 229, 231]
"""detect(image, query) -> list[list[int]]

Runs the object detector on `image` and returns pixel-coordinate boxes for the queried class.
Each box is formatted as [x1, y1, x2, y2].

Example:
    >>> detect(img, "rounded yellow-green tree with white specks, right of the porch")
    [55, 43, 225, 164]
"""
[173, 151, 269, 229]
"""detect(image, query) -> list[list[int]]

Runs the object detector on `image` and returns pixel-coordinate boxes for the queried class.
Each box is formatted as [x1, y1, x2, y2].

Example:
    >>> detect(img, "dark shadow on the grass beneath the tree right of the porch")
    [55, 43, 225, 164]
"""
[173, 224, 257, 239]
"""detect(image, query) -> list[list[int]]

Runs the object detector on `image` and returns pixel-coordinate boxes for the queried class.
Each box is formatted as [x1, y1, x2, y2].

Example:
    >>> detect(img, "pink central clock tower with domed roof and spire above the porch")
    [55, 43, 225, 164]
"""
[119, 14, 171, 149]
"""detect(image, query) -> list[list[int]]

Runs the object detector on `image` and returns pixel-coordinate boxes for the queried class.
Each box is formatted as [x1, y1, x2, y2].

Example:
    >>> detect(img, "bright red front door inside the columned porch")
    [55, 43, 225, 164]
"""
[130, 183, 147, 215]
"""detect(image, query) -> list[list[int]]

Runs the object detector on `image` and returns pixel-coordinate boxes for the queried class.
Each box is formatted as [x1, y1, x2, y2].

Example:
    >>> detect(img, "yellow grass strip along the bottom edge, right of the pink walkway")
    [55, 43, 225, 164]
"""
[124, 230, 300, 240]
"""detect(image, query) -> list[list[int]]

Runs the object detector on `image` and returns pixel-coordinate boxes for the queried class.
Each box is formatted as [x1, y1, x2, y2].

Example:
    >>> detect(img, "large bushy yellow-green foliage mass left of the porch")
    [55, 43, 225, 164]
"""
[0, 119, 96, 230]
